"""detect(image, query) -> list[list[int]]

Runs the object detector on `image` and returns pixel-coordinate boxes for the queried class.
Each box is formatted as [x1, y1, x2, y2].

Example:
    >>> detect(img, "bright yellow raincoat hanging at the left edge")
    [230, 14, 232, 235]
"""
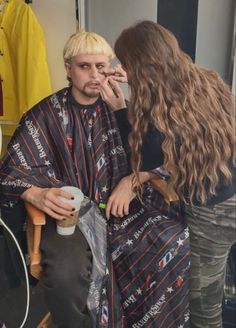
[0, 0, 51, 135]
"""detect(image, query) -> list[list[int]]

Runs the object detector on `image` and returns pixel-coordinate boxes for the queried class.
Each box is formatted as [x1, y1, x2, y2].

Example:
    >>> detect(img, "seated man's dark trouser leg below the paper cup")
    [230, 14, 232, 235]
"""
[41, 218, 92, 328]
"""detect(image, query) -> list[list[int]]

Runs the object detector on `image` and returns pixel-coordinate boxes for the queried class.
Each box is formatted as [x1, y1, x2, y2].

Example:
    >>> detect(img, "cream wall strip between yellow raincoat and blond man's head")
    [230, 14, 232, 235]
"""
[31, 0, 76, 91]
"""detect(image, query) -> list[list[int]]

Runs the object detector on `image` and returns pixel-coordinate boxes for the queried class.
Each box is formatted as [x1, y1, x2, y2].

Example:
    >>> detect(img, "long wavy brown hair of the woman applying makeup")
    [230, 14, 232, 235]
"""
[114, 21, 236, 204]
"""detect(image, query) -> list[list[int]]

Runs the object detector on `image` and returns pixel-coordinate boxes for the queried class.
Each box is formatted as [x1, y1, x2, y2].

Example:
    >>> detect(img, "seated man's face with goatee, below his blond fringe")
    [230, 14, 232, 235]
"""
[65, 55, 109, 105]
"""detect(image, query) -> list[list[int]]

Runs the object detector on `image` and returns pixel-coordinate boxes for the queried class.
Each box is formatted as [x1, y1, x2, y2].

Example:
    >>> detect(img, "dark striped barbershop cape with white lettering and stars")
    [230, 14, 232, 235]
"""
[0, 88, 189, 328]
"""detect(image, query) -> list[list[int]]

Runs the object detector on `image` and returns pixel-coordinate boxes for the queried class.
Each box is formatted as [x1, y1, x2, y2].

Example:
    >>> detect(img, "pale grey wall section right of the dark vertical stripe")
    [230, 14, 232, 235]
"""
[196, 0, 235, 80]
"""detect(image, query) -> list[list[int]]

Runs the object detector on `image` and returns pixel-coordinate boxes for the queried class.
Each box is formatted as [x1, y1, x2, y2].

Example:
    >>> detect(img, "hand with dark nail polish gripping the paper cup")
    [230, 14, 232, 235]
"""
[21, 187, 73, 220]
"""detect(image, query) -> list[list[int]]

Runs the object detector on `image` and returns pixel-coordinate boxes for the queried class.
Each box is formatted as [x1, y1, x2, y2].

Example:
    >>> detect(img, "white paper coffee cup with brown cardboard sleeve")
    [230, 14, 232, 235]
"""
[57, 186, 84, 236]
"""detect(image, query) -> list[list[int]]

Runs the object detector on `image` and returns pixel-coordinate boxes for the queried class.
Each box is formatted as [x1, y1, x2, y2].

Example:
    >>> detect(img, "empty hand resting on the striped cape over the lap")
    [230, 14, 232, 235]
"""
[105, 175, 135, 219]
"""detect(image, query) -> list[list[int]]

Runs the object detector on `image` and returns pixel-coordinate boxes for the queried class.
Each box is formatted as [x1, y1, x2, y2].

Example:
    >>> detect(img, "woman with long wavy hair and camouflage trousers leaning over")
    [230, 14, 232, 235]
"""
[108, 21, 236, 328]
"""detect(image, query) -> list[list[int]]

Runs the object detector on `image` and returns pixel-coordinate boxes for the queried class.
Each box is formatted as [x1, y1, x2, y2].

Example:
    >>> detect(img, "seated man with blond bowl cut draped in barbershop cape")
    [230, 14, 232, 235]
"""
[0, 32, 189, 328]
